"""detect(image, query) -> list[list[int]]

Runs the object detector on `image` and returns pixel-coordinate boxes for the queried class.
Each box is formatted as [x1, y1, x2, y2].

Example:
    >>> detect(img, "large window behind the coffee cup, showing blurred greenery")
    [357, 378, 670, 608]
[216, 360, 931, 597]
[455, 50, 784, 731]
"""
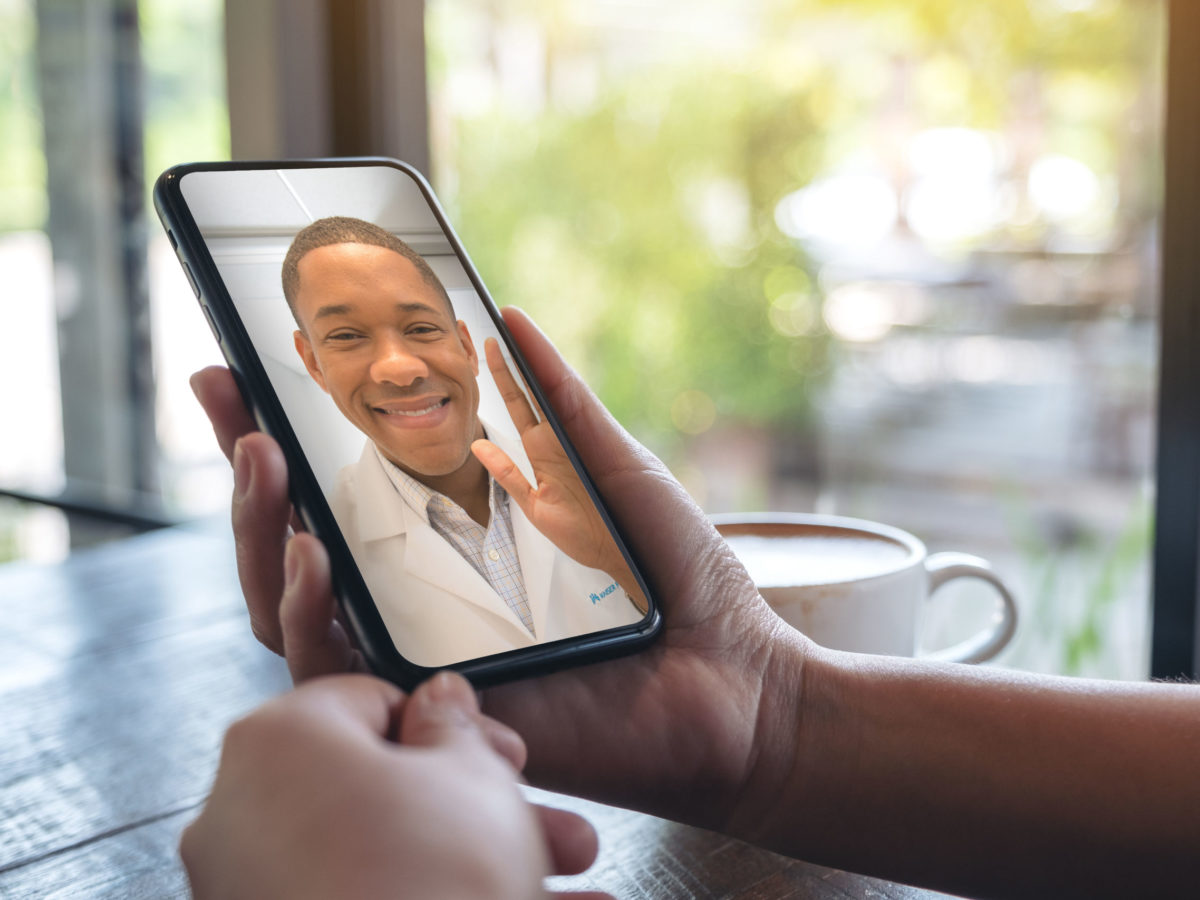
[427, 0, 1164, 677]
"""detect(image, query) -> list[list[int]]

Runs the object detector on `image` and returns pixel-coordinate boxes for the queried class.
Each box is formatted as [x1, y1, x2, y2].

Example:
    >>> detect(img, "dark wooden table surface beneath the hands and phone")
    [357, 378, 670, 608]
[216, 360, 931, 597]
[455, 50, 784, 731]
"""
[0, 523, 942, 899]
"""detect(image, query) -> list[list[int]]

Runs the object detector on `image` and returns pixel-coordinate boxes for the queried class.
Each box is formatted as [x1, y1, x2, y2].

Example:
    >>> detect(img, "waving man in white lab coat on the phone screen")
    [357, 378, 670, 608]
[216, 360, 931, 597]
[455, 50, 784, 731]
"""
[283, 216, 644, 666]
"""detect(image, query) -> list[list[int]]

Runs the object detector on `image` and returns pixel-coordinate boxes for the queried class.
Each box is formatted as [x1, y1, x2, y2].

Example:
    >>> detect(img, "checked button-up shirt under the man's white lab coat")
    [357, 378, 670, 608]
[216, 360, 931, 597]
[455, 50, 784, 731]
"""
[376, 448, 536, 637]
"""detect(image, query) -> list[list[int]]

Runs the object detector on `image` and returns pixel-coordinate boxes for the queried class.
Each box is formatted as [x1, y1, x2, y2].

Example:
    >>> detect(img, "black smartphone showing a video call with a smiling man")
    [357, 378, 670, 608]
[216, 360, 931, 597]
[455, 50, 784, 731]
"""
[154, 158, 661, 689]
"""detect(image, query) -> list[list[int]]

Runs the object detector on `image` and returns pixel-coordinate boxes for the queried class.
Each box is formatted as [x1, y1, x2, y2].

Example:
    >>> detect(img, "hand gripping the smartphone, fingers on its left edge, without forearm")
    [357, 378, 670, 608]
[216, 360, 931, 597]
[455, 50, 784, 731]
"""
[194, 307, 787, 828]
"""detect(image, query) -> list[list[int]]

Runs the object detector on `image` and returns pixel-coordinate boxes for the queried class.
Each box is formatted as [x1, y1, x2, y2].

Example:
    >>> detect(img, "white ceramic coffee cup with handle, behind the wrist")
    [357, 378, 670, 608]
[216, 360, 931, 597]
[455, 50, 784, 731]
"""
[713, 512, 1016, 662]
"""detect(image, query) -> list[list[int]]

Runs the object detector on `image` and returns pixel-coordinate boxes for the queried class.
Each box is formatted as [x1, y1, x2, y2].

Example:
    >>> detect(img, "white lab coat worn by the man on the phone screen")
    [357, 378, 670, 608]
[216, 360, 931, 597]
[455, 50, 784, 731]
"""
[330, 428, 642, 666]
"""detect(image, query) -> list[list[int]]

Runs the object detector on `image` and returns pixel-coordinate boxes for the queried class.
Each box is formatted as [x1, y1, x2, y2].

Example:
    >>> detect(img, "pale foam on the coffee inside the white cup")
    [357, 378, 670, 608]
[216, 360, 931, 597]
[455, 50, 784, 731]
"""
[726, 528, 912, 588]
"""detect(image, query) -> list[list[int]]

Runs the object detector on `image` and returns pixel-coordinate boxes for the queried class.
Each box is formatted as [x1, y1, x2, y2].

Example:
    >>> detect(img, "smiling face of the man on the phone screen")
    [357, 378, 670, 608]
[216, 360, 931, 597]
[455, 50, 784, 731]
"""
[295, 244, 482, 478]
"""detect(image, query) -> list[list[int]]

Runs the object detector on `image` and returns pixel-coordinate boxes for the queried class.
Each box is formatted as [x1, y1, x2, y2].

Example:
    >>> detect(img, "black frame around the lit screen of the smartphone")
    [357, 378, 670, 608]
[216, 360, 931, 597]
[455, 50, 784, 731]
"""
[154, 156, 662, 689]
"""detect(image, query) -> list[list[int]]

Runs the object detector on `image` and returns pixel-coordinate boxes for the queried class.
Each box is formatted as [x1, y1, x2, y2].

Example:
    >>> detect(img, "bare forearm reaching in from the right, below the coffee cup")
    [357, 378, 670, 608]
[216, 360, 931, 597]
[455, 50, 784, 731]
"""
[737, 652, 1200, 898]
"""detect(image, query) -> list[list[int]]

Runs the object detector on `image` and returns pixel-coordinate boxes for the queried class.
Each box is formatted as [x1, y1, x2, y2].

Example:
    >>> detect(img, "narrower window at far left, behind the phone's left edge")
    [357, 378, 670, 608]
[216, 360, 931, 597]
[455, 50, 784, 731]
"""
[0, 0, 228, 559]
